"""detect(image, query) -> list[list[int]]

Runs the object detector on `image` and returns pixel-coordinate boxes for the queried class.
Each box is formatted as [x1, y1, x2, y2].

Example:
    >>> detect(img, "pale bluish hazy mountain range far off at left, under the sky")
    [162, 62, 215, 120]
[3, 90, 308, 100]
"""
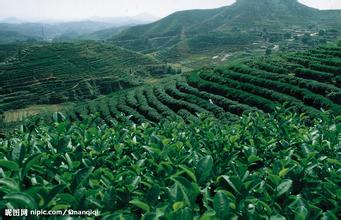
[0, 14, 156, 43]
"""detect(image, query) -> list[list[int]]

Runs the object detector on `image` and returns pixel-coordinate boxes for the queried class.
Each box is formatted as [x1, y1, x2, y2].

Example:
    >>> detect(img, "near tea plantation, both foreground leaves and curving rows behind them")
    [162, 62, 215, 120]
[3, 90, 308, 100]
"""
[0, 46, 341, 220]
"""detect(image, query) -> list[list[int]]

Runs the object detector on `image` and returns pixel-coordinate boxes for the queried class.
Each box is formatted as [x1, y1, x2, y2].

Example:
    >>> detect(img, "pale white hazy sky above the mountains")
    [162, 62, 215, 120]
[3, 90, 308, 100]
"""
[0, 0, 341, 20]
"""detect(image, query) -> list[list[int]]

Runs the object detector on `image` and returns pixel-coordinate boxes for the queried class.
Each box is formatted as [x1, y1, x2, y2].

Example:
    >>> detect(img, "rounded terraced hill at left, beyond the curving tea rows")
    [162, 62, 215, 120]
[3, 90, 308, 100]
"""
[0, 42, 178, 111]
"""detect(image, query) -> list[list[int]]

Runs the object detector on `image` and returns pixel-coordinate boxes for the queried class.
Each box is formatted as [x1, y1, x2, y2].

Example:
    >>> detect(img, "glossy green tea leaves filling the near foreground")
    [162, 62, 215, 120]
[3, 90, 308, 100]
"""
[0, 108, 341, 219]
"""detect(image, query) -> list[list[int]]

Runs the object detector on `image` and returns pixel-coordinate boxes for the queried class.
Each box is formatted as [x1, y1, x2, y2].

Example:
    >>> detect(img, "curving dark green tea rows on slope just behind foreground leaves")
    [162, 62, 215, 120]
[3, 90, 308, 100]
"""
[65, 46, 341, 125]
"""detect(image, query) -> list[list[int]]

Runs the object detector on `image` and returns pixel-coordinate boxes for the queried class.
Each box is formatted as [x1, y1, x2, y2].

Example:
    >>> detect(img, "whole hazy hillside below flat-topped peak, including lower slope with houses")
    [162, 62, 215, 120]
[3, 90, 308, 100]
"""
[113, 0, 341, 60]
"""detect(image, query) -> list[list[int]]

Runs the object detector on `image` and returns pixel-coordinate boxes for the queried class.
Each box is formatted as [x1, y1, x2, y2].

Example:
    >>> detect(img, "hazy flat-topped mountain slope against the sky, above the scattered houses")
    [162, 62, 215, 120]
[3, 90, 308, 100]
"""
[112, 0, 341, 53]
